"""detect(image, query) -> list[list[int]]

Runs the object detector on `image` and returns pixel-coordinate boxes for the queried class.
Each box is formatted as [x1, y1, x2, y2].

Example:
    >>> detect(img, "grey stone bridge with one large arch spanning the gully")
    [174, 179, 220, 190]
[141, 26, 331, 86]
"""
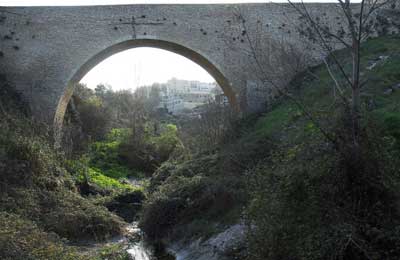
[0, 3, 384, 137]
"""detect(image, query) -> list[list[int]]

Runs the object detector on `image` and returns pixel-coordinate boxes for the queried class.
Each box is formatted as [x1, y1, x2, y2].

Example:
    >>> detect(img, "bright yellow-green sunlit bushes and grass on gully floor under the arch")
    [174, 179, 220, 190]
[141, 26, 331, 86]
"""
[67, 124, 180, 191]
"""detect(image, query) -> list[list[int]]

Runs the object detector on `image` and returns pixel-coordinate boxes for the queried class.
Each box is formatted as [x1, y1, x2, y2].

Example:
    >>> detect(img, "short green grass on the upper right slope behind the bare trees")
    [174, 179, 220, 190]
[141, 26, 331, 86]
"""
[252, 37, 400, 142]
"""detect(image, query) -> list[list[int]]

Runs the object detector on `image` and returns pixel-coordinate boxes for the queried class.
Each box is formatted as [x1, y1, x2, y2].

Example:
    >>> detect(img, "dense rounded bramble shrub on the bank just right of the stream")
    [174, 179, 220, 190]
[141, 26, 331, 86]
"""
[140, 151, 246, 240]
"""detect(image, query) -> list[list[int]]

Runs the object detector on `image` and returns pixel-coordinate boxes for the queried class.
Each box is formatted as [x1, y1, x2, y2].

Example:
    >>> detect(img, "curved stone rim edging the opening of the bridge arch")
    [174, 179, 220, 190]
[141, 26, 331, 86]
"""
[53, 39, 240, 144]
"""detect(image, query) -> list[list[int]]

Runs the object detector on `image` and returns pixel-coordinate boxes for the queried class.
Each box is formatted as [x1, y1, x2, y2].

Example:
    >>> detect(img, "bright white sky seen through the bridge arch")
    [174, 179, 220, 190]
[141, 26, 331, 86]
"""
[81, 47, 215, 90]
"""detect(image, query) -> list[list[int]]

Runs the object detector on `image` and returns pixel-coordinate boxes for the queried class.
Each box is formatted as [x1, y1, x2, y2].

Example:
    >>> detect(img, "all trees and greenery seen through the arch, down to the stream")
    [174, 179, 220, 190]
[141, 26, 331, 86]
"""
[64, 85, 182, 235]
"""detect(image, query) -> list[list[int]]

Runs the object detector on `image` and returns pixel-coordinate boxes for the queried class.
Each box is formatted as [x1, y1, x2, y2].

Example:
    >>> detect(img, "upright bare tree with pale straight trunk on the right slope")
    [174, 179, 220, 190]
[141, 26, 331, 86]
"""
[288, 0, 395, 157]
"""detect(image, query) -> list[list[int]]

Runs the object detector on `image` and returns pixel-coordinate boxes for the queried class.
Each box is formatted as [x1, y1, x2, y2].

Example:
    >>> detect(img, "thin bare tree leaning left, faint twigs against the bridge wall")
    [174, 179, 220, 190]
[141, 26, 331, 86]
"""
[227, 8, 335, 142]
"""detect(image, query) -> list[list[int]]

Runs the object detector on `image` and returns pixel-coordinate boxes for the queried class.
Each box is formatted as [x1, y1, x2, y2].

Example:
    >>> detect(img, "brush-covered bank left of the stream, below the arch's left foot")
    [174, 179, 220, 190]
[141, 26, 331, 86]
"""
[0, 84, 128, 259]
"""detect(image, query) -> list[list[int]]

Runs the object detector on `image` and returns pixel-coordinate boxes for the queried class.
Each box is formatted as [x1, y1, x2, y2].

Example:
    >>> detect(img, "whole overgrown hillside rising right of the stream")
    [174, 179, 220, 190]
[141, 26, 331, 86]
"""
[142, 37, 400, 259]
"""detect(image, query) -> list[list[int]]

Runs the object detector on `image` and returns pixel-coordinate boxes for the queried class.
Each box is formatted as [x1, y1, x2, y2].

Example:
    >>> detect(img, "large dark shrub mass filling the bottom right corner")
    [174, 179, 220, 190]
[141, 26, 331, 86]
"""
[246, 123, 400, 259]
